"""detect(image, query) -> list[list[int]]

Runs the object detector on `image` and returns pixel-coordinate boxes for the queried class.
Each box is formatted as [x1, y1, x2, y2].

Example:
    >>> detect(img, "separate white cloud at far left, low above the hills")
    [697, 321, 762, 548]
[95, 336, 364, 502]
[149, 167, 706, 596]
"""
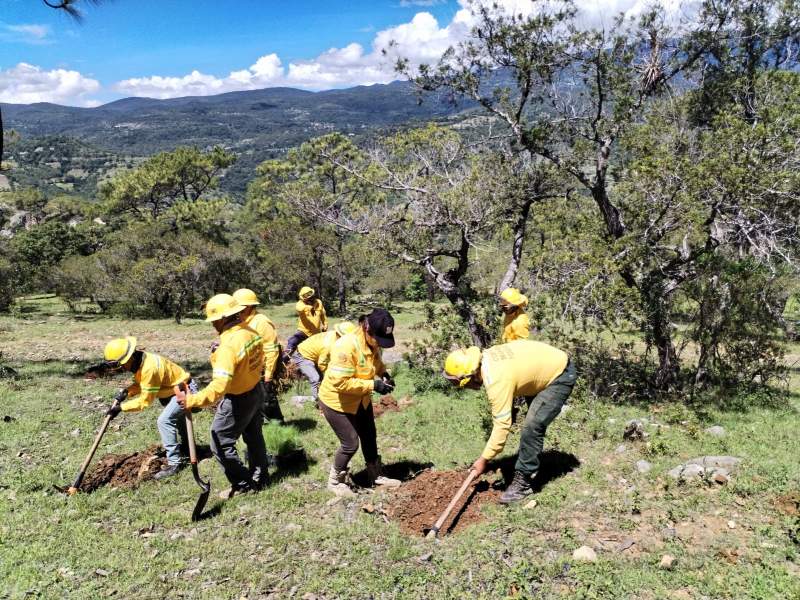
[0, 63, 100, 106]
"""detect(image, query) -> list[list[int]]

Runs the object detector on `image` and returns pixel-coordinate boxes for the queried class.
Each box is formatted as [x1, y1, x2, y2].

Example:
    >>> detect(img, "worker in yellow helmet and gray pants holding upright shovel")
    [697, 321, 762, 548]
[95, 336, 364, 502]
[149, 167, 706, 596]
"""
[178, 294, 269, 499]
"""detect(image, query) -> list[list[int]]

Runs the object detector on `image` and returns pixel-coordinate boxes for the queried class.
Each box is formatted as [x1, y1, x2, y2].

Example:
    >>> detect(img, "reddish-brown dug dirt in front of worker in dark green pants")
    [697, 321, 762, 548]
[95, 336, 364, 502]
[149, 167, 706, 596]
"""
[386, 469, 500, 536]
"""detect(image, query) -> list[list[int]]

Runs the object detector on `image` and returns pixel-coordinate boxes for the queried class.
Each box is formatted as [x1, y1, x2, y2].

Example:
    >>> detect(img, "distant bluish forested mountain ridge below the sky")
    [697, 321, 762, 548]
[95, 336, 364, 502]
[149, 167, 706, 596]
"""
[2, 82, 470, 196]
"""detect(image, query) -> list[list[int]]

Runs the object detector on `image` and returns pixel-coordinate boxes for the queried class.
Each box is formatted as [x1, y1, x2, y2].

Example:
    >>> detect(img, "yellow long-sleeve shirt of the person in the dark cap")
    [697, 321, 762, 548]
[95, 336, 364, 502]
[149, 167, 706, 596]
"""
[319, 327, 386, 415]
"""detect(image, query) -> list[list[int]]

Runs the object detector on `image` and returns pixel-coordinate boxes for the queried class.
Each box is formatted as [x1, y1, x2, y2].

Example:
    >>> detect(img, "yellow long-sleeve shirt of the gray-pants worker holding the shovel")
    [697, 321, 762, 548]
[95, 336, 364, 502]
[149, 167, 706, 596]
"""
[186, 325, 264, 408]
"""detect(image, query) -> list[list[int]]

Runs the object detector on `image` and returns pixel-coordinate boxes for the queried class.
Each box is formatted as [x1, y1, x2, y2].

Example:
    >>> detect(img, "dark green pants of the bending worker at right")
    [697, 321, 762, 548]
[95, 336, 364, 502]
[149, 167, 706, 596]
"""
[515, 361, 578, 476]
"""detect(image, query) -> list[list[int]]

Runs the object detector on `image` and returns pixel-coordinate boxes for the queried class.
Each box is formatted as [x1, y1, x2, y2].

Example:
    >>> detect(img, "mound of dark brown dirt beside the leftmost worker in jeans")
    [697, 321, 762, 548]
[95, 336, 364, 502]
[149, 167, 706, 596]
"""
[81, 445, 167, 492]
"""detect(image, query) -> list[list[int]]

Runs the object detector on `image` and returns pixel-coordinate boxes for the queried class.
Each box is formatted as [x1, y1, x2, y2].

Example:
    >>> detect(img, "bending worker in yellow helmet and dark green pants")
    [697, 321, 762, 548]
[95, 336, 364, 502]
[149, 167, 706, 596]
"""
[444, 340, 577, 504]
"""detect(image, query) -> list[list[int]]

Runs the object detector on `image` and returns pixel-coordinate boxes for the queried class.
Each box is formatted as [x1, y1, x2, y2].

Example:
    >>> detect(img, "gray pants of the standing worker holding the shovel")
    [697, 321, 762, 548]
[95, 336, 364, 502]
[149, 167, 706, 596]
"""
[211, 384, 269, 490]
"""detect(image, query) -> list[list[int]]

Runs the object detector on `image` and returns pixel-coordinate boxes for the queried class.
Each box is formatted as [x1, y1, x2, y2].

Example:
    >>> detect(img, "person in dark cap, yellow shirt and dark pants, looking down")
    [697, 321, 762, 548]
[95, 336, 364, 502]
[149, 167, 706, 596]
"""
[319, 308, 400, 496]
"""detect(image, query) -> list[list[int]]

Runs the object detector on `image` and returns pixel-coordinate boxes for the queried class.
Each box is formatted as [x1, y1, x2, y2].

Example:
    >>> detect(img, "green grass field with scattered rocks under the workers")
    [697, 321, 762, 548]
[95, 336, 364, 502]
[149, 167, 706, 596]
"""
[0, 298, 800, 599]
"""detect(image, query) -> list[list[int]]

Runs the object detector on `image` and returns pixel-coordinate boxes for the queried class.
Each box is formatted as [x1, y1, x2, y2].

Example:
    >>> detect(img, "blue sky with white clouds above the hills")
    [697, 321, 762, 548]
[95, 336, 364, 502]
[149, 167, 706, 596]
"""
[0, 0, 676, 106]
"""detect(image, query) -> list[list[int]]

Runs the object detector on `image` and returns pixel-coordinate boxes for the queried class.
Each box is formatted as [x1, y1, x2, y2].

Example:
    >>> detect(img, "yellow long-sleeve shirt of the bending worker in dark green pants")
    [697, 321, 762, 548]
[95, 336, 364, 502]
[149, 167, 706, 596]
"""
[481, 340, 569, 460]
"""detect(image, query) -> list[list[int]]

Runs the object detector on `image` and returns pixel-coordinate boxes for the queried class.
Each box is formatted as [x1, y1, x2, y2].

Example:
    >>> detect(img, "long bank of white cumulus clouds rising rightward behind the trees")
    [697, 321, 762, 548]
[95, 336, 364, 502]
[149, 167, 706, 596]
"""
[115, 0, 697, 98]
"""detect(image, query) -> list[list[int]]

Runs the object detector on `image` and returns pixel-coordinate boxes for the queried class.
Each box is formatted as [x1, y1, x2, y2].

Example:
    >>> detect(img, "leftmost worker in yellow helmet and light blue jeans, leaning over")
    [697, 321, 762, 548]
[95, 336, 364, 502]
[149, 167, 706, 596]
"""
[103, 337, 197, 479]
